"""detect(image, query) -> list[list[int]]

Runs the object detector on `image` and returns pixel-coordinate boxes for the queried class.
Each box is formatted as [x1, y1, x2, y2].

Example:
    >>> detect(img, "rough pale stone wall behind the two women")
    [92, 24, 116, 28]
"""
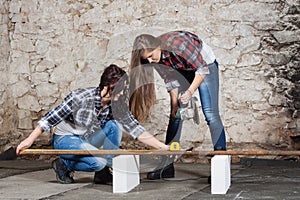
[0, 0, 300, 152]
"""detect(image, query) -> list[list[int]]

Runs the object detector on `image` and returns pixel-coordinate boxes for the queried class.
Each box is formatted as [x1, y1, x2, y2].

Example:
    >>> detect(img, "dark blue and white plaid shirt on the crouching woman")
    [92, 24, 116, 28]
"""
[38, 87, 145, 138]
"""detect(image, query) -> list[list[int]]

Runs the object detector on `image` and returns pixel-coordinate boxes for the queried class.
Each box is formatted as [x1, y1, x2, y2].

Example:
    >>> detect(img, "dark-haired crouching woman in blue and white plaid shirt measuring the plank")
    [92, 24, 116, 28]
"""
[16, 65, 169, 184]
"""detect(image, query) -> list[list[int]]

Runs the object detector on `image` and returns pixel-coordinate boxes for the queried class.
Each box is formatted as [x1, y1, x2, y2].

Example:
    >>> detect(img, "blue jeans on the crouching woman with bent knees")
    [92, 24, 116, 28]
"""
[53, 120, 122, 172]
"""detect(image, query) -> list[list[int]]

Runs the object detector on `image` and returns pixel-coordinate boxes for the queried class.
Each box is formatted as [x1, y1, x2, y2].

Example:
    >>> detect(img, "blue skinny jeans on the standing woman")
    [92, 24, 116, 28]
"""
[166, 61, 226, 150]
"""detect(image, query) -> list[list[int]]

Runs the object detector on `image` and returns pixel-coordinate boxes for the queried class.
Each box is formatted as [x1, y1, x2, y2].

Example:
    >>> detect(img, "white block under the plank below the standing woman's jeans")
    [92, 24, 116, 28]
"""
[211, 155, 231, 194]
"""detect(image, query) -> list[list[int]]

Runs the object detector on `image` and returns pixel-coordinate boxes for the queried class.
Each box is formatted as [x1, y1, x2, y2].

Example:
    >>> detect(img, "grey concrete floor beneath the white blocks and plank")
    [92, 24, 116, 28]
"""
[0, 158, 300, 200]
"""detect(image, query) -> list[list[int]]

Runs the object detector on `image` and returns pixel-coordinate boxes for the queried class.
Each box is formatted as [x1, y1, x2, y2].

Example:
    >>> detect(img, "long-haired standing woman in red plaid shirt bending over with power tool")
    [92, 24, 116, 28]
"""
[130, 31, 226, 179]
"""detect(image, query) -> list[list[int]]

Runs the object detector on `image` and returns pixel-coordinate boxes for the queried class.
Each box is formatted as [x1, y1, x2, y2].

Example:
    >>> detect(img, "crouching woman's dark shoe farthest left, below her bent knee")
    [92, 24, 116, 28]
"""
[52, 158, 74, 184]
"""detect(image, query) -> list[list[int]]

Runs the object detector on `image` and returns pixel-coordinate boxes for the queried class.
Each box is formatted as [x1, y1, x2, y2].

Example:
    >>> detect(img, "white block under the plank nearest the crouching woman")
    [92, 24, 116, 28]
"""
[112, 155, 140, 193]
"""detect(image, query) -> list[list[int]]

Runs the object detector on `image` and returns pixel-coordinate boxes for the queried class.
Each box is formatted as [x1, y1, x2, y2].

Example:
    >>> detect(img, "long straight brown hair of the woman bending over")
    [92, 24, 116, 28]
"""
[129, 34, 160, 122]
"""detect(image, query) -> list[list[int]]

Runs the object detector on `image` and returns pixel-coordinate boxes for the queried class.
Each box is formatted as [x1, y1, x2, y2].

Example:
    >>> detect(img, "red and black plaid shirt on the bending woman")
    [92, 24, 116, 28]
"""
[158, 31, 215, 91]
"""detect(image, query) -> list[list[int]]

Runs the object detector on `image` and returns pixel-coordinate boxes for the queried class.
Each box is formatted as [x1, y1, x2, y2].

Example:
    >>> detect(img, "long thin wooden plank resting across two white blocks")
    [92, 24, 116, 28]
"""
[20, 149, 300, 156]
